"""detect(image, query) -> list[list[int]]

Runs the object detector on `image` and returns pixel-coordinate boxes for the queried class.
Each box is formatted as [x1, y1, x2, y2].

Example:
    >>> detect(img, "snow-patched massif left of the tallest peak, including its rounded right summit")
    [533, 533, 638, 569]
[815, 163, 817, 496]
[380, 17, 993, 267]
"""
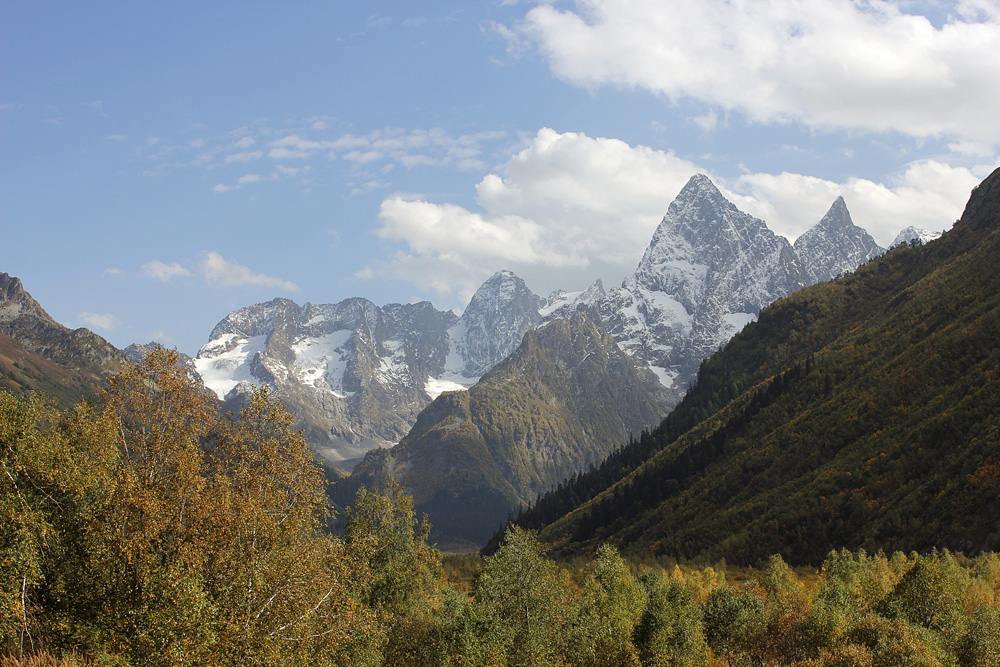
[195, 271, 556, 461]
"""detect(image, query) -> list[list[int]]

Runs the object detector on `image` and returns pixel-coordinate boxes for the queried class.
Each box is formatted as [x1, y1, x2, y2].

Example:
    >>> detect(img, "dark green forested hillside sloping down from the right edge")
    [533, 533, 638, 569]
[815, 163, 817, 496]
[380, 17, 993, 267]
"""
[521, 166, 1000, 563]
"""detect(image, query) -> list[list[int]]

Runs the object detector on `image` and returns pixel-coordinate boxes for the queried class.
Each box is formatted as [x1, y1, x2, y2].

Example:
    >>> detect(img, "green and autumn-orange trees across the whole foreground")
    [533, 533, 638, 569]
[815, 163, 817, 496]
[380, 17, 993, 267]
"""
[0, 352, 1000, 667]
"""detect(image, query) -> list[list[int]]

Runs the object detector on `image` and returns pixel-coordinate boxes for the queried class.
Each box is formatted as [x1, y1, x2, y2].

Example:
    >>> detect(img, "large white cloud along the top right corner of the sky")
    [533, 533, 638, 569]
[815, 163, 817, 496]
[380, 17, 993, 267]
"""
[501, 0, 1000, 145]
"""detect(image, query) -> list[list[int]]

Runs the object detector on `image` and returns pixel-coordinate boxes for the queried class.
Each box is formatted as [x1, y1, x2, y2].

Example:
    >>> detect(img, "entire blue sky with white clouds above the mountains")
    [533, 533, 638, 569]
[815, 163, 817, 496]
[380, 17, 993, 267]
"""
[0, 0, 1000, 355]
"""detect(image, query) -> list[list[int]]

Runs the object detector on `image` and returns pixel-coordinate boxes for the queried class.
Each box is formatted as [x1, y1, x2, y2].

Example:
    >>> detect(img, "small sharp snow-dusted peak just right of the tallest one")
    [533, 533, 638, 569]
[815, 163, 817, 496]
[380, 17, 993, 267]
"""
[794, 197, 885, 283]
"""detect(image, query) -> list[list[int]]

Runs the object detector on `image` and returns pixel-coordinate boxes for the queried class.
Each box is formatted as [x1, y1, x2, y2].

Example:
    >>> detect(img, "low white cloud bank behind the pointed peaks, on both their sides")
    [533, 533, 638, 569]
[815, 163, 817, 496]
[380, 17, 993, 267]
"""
[364, 128, 979, 305]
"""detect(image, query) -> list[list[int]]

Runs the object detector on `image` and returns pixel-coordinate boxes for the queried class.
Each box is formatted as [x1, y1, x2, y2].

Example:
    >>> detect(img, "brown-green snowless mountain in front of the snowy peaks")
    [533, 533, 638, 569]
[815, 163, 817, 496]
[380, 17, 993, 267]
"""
[345, 307, 665, 544]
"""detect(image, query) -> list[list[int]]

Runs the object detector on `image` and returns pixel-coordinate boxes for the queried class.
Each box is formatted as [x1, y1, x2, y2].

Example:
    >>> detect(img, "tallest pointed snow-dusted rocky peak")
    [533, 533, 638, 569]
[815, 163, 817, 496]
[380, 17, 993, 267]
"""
[600, 175, 812, 405]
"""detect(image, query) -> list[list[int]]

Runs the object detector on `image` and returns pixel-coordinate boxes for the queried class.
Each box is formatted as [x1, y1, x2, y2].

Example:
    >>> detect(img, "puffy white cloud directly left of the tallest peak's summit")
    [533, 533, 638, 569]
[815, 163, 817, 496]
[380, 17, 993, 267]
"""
[370, 128, 698, 294]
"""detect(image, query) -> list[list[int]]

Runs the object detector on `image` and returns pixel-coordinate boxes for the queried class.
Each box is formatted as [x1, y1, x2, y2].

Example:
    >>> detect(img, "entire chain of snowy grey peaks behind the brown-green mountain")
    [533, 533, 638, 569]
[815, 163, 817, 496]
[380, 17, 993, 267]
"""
[186, 175, 881, 472]
